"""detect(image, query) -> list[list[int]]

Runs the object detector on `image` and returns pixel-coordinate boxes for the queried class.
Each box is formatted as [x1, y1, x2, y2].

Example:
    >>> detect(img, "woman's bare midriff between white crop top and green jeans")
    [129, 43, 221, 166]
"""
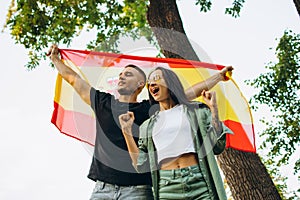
[160, 153, 198, 170]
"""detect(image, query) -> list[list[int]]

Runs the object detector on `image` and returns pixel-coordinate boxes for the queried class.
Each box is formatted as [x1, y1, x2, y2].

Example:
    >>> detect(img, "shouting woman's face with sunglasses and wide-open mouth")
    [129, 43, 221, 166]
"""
[147, 70, 170, 102]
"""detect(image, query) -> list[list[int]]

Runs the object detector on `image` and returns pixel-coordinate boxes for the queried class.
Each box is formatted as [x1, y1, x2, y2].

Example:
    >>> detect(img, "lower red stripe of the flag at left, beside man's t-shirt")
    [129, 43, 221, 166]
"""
[51, 102, 96, 145]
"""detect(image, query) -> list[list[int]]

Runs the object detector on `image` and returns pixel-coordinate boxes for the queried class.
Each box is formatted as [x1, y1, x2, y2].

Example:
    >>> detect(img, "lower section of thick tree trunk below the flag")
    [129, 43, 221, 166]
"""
[218, 148, 281, 200]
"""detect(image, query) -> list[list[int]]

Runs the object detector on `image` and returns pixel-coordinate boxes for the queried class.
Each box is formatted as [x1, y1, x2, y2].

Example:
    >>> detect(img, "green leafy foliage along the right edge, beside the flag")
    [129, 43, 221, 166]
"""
[248, 30, 300, 195]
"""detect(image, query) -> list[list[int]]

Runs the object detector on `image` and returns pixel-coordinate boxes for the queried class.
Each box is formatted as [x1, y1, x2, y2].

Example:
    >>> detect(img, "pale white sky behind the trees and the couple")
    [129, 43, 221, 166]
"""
[0, 0, 300, 200]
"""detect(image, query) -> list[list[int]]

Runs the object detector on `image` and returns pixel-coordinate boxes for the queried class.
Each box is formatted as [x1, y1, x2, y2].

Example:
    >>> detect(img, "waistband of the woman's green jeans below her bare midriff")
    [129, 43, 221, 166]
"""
[159, 165, 201, 178]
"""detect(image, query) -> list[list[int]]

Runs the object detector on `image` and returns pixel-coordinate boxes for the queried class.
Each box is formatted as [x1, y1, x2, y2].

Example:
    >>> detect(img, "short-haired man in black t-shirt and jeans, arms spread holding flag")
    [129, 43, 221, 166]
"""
[47, 45, 233, 200]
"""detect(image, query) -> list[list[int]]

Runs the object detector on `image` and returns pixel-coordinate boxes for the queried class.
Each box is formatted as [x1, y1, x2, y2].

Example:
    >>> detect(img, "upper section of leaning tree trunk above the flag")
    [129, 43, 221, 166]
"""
[147, 0, 199, 60]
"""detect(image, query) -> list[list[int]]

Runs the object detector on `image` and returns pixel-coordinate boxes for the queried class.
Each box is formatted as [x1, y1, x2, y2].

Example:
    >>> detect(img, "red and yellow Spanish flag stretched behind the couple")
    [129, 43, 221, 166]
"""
[51, 49, 256, 152]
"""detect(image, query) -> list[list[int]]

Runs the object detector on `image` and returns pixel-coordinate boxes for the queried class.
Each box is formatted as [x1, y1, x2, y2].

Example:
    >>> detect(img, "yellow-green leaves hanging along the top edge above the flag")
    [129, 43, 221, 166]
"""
[4, 0, 244, 69]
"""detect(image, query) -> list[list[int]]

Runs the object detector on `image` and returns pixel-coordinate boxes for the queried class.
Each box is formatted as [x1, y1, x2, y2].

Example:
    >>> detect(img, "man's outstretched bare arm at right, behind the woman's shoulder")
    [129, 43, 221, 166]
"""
[185, 66, 233, 100]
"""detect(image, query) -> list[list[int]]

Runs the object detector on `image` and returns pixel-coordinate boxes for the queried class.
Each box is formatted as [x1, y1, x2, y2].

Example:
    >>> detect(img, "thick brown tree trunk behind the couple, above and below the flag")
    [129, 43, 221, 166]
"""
[147, 0, 282, 200]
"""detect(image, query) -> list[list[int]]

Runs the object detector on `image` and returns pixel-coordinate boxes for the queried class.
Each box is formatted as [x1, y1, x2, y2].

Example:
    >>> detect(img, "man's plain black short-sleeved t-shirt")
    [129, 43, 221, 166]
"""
[88, 88, 151, 186]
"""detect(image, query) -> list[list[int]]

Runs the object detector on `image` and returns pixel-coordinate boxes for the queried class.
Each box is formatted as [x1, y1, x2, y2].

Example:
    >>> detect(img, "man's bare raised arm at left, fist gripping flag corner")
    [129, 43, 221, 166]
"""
[47, 45, 91, 105]
